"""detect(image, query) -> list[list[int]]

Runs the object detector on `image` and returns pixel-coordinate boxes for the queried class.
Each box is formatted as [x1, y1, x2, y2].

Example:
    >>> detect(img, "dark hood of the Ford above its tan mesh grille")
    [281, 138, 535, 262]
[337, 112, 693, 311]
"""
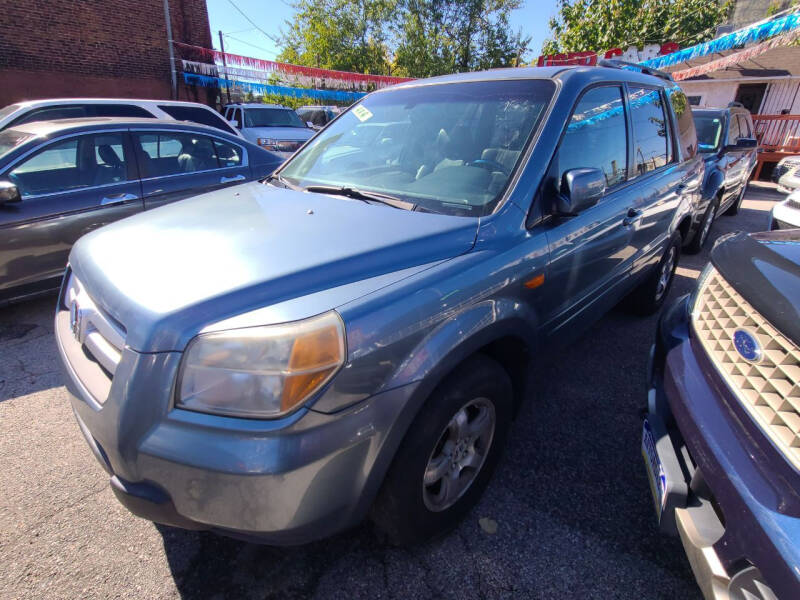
[711, 229, 800, 344]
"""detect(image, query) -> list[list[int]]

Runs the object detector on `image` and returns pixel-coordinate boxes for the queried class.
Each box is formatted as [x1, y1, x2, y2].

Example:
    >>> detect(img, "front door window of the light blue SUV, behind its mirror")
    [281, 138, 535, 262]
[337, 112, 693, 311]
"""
[554, 86, 628, 187]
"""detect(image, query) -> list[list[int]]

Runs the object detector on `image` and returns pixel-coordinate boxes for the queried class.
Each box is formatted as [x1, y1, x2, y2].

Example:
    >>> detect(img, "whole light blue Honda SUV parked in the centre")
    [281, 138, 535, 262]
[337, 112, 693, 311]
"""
[56, 65, 703, 544]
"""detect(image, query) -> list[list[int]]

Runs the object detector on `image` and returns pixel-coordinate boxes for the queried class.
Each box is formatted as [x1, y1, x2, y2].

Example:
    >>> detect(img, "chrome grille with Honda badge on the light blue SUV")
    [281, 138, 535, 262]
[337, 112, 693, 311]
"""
[64, 275, 126, 377]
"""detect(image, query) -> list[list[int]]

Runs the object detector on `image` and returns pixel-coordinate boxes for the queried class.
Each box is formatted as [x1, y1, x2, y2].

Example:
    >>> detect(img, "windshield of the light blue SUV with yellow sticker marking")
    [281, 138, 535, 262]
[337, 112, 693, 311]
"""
[280, 79, 555, 216]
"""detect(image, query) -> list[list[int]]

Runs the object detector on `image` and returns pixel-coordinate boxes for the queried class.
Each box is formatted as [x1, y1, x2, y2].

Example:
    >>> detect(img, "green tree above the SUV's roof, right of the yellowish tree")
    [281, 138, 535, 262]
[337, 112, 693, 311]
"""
[394, 0, 530, 77]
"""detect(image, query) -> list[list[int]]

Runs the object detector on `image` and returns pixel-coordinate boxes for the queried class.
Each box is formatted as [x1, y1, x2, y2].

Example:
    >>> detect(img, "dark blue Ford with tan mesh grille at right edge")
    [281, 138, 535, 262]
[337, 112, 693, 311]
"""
[642, 230, 800, 600]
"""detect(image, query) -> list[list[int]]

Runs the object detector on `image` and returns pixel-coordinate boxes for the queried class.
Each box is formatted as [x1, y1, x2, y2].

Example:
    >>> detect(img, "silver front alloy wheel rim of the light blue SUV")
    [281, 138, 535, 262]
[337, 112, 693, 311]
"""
[422, 398, 497, 512]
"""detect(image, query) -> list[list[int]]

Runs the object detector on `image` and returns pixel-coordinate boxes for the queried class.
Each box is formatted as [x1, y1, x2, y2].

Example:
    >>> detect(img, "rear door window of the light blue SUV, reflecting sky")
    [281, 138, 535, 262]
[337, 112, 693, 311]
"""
[628, 87, 671, 175]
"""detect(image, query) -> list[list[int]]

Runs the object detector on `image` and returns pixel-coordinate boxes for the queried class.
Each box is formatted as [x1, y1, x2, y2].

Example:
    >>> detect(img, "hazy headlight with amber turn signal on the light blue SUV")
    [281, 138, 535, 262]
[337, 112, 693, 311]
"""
[176, 311, 345, 418]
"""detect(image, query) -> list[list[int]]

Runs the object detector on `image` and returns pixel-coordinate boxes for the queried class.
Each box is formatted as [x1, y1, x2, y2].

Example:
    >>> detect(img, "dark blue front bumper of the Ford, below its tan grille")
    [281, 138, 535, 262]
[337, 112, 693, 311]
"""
[646, 297, 800, 600]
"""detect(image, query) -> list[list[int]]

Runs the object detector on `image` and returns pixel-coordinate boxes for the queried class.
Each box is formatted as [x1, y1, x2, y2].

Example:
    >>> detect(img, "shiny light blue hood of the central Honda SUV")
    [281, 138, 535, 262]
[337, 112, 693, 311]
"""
[70, 182, 478, 352]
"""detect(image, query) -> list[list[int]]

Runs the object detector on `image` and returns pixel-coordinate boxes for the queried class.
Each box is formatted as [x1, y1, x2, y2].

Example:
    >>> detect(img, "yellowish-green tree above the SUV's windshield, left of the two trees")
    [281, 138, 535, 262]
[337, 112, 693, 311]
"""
[278, 0, 396, 74]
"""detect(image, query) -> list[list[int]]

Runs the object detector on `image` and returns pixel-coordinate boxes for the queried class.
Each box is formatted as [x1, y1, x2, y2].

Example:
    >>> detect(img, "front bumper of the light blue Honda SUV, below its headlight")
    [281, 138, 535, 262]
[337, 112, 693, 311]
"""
[56, 304, 417, 545]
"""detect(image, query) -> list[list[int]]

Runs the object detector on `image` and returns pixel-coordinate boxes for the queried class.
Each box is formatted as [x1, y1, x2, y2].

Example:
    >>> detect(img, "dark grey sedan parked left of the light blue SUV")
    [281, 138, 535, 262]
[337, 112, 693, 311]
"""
[0, 118, 282, 305]
